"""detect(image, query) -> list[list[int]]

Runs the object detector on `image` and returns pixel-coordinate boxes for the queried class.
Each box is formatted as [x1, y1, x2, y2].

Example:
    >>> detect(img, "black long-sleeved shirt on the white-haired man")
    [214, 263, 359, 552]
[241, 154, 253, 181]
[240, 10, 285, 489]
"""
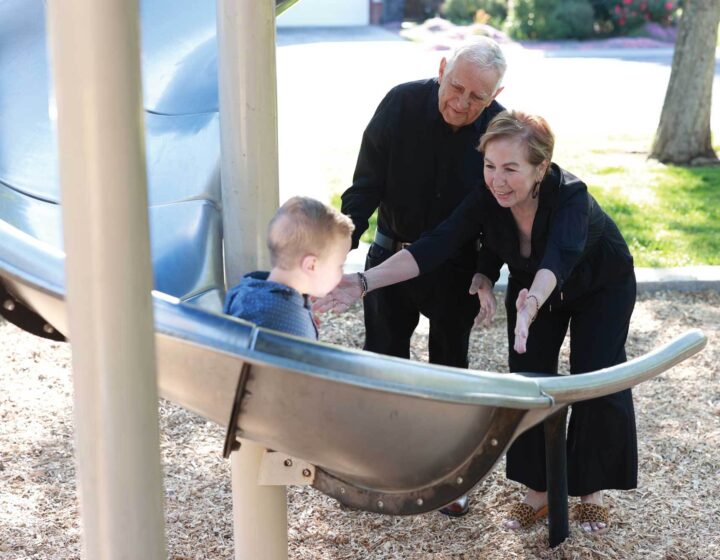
[342, 79, 503, 266]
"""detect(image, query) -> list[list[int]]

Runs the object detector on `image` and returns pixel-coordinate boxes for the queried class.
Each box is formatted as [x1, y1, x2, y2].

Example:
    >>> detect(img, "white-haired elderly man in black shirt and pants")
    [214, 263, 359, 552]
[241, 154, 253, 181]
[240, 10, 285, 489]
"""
[342, 38, 506, 376]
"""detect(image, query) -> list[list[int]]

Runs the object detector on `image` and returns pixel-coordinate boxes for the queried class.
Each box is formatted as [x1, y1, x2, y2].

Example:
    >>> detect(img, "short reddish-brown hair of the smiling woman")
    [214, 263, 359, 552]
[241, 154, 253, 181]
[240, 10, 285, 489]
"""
[478, 111, 555, 165]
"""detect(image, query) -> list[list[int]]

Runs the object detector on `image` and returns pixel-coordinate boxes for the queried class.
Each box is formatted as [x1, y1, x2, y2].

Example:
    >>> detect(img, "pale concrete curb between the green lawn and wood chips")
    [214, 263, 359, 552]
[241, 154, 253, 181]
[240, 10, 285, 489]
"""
[345, 246, 720, 293]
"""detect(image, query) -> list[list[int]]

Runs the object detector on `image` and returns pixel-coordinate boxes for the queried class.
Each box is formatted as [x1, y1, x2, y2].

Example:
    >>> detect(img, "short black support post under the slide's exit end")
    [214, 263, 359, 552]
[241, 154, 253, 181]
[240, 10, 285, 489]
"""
[545, 407, 570, 548]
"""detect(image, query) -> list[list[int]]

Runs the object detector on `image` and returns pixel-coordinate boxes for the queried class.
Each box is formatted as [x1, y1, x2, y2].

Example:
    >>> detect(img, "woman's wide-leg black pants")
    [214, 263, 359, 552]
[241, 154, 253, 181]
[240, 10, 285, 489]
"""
[505, 272, 637, 496]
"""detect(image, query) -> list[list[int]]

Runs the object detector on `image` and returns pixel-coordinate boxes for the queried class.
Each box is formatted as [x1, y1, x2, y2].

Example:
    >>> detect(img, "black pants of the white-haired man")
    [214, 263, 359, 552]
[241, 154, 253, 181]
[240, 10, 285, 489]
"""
[363, 243, 479, 368]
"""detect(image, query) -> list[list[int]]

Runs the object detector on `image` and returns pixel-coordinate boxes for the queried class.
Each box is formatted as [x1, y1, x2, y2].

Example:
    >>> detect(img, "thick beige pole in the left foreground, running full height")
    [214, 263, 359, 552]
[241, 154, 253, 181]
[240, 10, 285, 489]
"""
[48, 0, 166, 560]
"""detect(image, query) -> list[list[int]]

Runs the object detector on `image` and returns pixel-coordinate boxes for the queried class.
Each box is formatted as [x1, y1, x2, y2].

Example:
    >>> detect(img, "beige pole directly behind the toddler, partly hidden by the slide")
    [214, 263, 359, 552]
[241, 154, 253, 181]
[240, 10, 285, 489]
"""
[217, 0, 287, 560]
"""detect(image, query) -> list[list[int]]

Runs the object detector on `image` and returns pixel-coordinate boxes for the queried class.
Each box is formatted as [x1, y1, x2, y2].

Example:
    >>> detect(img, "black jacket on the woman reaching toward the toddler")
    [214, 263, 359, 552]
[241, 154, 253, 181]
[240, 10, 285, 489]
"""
[408, 163, 633, 302]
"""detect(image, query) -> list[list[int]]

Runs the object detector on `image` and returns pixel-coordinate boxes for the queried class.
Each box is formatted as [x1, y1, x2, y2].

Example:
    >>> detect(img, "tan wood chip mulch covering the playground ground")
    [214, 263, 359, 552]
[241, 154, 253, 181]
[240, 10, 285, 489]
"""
[0, 291, 720, 560]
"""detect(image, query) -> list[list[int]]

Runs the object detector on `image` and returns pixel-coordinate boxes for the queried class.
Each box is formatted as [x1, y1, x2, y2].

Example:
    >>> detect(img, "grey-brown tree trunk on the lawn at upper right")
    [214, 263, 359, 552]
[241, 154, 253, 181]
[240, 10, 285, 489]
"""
[650, 0, 720, 165]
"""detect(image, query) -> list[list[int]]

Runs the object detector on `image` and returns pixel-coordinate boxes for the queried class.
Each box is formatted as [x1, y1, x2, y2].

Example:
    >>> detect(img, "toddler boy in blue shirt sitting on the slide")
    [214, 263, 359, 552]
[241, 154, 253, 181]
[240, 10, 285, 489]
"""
[224, 196, 354, 339]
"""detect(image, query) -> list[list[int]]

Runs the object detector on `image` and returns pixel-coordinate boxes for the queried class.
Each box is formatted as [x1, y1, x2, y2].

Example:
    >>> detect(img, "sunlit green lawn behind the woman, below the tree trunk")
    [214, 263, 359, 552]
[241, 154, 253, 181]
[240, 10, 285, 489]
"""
[333, 135, 720, 267]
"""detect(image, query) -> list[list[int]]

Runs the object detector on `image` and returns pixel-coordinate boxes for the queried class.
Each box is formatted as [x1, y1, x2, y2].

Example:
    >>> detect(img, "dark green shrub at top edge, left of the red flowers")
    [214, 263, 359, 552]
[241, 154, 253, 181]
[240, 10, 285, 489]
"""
[506, 0, 592, 39]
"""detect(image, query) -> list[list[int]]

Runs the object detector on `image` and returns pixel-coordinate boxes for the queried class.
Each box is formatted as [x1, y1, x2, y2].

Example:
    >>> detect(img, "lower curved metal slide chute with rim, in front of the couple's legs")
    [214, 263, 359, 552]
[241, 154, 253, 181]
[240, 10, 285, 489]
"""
[0, 203, 706, 514]
